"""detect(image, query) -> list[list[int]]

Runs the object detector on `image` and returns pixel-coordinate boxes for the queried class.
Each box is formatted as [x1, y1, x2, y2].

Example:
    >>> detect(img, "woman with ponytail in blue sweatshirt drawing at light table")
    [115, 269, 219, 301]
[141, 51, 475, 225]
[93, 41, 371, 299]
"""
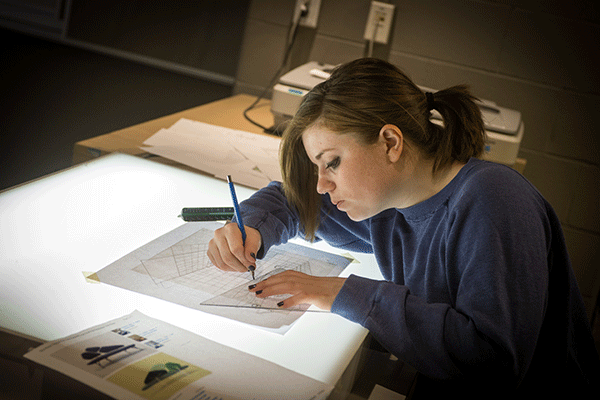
[208, 59, 600, 397]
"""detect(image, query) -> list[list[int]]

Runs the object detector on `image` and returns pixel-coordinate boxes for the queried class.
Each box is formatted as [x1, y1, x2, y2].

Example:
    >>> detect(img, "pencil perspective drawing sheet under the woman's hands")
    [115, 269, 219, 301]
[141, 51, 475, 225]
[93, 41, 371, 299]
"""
[98, 222, 350, 328]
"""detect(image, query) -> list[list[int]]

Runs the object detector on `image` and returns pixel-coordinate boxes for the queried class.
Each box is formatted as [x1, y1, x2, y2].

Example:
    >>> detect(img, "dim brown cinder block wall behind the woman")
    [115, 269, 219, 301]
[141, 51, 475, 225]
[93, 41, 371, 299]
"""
[234, 0, 600, 317]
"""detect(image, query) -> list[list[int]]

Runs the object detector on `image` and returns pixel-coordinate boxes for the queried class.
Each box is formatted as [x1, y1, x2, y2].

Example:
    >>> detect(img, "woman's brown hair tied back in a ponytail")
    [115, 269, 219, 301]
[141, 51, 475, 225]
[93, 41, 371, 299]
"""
[280, 58, 485, 239]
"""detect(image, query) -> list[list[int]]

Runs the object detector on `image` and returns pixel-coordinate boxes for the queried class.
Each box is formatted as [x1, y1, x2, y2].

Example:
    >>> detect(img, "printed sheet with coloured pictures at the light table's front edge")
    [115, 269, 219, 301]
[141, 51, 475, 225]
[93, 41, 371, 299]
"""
[25, 311, 333, 400]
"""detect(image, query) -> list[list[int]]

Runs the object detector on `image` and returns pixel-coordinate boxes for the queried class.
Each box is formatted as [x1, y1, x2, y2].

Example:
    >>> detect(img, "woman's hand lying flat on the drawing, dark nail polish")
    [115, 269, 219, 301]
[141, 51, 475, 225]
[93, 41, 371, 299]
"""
[248, 271, 346, 311]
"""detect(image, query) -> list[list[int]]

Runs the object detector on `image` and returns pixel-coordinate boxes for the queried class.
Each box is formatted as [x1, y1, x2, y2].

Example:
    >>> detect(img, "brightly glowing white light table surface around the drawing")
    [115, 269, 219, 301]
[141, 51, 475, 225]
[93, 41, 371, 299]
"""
[0, 153, 380, 396]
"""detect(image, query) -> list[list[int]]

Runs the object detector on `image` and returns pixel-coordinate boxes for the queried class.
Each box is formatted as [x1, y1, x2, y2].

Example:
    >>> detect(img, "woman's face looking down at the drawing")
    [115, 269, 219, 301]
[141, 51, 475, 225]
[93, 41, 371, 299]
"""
[302, 124, 395, 221]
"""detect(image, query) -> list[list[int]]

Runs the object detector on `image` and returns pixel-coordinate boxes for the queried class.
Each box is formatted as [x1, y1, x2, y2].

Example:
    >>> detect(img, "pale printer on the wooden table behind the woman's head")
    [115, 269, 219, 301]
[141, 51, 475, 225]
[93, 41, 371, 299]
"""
[271, 61, 525, 165]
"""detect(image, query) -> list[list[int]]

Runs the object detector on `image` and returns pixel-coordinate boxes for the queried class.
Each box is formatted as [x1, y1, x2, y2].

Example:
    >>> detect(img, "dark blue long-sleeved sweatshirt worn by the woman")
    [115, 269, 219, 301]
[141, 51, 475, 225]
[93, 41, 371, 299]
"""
[237, 159, 600, 395]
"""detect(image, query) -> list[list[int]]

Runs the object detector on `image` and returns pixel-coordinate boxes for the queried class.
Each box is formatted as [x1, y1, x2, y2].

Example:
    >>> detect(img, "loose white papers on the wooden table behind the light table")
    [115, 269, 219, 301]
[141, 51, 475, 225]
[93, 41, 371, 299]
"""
[140, 118, 281, 189]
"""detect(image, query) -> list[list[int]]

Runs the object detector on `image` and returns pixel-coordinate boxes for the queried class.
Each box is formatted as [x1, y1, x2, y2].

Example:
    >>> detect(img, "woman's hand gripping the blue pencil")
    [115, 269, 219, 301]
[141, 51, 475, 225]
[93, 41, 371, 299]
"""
[206, 223, 262, 272]
